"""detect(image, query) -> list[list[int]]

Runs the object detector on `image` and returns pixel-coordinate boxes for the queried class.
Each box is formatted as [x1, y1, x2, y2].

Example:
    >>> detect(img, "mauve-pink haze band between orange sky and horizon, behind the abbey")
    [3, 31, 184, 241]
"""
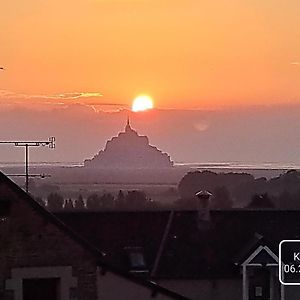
[0, 104, 300, 163]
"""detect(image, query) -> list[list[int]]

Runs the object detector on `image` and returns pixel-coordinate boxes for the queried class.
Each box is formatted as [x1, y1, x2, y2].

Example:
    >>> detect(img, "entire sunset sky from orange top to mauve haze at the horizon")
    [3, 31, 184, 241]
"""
[0, 0, 300, 163]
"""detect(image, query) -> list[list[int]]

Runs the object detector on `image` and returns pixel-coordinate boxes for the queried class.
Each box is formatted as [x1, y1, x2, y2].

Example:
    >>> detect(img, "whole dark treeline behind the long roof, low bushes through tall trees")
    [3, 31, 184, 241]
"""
[36, 170, 300, 211]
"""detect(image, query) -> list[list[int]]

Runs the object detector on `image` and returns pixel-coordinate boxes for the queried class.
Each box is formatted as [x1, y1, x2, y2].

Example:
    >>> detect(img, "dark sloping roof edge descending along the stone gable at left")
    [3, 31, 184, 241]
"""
[0, 172, 190, 300]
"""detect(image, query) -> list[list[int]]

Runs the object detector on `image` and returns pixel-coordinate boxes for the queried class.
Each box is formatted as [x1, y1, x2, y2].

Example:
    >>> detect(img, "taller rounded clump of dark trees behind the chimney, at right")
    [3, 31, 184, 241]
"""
[178, 170, 300, 209]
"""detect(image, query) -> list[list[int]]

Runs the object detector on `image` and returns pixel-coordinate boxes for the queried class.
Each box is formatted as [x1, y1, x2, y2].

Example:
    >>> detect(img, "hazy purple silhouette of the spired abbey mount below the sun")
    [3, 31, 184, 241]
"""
[84, 119, 173, 169]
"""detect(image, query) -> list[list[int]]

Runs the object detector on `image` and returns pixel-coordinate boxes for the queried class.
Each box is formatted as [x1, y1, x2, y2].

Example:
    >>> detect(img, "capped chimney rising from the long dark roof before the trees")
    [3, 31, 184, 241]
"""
[196, 190, 212, 230]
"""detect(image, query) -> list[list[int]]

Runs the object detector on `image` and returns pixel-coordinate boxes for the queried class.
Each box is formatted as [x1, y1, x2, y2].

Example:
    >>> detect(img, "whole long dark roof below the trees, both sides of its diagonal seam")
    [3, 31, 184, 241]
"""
[56, 209, 300, 278]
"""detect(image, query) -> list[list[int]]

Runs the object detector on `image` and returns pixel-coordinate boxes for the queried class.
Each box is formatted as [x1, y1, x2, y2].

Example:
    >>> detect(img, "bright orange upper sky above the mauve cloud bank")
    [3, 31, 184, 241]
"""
[0, 0, 300, 109]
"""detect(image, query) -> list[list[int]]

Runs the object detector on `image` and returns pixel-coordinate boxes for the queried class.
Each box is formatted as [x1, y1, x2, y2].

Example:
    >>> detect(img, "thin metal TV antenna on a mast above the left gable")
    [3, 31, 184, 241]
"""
[0, 136, 55, 193]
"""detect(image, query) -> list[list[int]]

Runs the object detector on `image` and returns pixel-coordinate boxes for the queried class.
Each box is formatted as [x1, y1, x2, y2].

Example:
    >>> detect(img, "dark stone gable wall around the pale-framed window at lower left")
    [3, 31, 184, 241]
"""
[0, 184, 97, 300]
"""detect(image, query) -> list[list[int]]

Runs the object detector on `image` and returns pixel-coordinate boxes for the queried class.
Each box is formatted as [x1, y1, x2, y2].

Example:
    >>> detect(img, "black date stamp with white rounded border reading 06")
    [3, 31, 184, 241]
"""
[279, 240, 300, 285]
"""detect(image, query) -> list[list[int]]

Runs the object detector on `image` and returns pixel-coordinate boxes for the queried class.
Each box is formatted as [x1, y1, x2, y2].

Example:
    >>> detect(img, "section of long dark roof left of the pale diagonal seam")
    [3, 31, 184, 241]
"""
[56, 211, 170, 269]
